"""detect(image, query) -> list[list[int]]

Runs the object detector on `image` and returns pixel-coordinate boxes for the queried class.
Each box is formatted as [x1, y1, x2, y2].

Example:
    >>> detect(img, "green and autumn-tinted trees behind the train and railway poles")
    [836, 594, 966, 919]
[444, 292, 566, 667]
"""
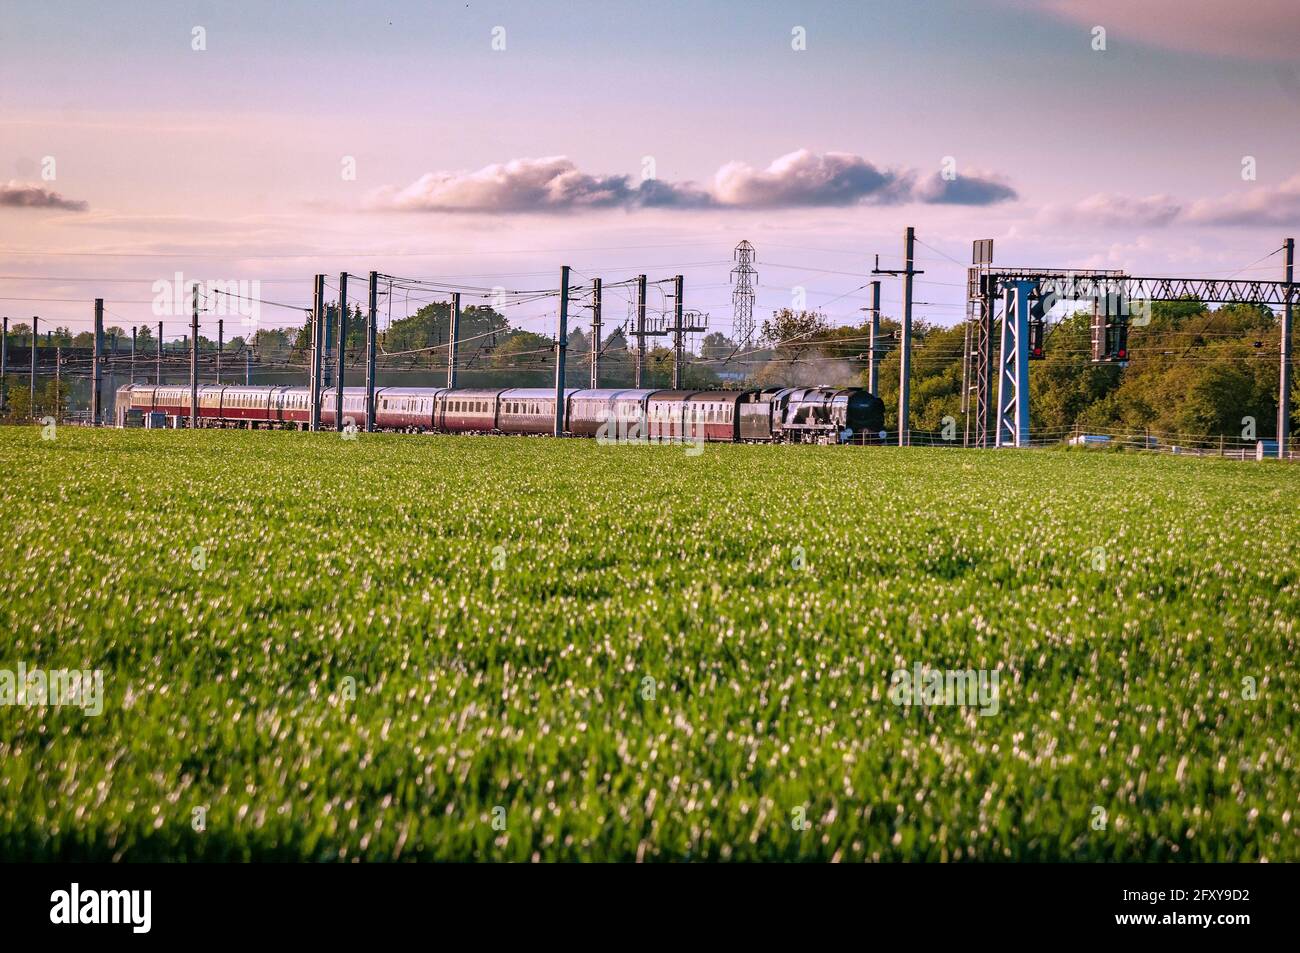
[8, 300, 1300, 439]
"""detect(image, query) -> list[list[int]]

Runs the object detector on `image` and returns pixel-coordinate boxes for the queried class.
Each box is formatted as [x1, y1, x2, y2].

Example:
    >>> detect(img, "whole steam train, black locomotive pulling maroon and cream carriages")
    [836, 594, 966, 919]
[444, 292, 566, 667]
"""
[117, 384, 884, 443]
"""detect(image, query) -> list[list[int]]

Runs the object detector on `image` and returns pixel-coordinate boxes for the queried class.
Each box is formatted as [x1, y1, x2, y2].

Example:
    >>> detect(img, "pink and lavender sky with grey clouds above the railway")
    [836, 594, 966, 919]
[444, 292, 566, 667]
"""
[0, 0, 1300, 338]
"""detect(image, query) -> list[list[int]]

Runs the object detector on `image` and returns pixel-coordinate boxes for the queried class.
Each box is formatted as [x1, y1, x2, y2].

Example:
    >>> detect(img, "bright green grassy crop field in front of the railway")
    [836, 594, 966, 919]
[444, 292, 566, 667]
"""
[0, 428, 1300, 861]
